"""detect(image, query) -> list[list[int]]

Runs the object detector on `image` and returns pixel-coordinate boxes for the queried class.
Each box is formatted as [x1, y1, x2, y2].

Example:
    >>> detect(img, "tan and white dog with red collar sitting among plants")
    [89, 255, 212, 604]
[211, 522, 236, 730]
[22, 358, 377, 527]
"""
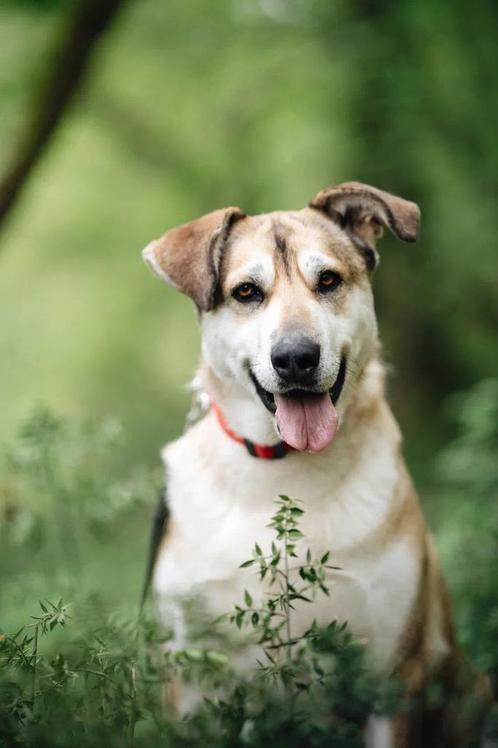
[143, 182, 487, 748]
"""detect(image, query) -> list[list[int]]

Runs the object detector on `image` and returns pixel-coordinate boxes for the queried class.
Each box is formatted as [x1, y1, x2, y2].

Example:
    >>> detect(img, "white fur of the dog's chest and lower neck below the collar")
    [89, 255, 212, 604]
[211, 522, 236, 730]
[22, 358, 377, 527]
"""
[154, 394, 418, 670]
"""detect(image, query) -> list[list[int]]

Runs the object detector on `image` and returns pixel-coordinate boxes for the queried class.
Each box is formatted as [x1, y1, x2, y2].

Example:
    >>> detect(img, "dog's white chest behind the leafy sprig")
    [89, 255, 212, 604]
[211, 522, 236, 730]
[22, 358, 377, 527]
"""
[154, 420, 417, 667]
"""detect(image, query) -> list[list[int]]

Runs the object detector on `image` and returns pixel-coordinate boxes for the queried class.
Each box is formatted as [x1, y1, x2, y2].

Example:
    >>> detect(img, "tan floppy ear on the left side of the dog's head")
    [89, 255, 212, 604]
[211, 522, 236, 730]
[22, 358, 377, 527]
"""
[142, 208, 245, 311]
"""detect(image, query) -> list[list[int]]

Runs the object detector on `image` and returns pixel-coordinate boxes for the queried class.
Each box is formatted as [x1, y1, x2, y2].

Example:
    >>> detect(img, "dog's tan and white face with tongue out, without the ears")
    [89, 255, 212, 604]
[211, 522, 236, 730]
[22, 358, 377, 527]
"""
[201, 209, 377, 451]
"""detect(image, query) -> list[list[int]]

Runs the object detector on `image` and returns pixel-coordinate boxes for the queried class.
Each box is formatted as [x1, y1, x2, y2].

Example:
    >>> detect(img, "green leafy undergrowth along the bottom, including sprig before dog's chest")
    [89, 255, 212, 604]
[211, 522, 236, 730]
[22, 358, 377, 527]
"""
[0, 490, 397, 748]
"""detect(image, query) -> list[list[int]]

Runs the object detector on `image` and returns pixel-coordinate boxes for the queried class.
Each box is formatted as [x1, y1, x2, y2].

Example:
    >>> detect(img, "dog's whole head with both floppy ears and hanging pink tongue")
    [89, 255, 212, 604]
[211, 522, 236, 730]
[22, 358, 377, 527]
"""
[143, 182, 420, 452]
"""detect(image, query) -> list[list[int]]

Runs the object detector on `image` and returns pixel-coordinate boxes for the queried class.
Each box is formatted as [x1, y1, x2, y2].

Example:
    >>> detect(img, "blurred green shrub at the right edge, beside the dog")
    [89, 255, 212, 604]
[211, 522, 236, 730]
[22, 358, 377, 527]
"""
[436, 379, 498, 684]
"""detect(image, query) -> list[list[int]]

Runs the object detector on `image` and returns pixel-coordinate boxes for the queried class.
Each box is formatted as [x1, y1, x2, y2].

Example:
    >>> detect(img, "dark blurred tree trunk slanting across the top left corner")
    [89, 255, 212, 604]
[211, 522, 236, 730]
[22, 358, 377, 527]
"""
[0, 0, 126, 235]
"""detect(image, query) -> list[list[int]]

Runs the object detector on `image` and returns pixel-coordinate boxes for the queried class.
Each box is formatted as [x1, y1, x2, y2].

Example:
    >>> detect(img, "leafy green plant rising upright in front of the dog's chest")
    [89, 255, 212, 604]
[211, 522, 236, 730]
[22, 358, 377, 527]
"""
[222, 496, 400, 746]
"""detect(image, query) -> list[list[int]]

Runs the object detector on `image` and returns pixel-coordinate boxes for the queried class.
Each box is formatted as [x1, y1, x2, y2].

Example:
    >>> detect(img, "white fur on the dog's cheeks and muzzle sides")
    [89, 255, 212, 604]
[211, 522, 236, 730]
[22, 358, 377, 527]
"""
[201, 274, 377, 443]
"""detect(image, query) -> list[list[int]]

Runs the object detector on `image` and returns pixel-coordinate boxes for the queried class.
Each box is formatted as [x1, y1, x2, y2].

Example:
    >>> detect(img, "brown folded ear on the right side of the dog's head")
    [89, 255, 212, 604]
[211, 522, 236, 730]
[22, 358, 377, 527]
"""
[309, 182, 420, 269]
